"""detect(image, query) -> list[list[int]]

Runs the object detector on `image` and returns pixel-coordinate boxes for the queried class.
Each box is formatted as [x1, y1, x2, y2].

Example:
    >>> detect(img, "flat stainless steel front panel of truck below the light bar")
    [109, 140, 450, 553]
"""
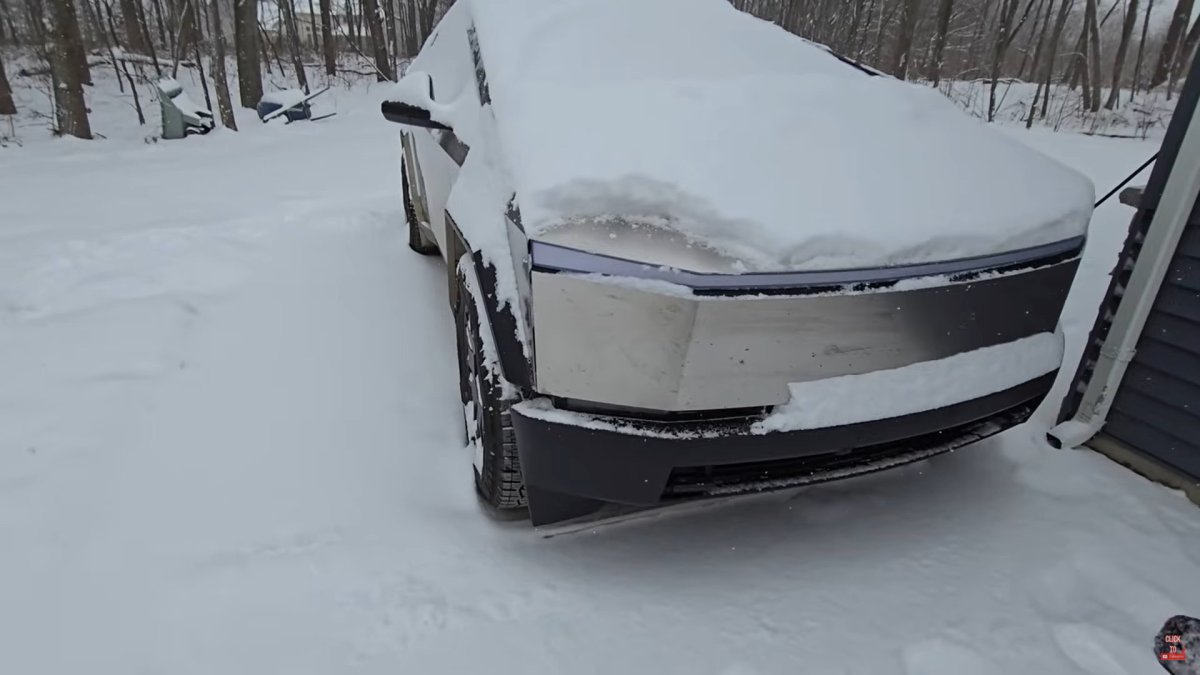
[532, 258, 1079, 411]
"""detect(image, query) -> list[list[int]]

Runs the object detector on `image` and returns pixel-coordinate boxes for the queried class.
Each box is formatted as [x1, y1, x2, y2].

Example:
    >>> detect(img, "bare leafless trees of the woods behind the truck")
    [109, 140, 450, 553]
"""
[0, 0, 1200, 138]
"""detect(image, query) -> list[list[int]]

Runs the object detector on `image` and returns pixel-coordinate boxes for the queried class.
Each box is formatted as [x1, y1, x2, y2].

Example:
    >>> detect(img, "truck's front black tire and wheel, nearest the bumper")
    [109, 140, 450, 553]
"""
[455, 263, 528, 509]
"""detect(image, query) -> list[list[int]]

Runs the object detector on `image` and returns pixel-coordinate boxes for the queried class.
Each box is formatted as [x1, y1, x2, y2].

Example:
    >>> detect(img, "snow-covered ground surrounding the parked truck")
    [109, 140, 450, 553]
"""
[0, 73, 1200, 675]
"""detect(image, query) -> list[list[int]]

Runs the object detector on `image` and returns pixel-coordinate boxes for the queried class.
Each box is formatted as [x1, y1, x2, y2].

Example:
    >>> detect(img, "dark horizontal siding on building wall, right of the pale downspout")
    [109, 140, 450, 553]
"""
[1104, 203, 1200, 479]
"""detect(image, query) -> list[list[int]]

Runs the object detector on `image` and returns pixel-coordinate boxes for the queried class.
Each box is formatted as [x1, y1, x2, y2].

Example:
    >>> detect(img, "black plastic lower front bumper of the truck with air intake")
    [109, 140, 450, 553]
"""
[512, 372, 1056, 525]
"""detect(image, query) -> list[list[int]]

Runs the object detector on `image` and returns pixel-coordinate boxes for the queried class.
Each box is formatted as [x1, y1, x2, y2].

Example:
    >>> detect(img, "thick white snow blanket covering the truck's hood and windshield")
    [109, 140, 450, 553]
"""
[468, 0, 1094, 269]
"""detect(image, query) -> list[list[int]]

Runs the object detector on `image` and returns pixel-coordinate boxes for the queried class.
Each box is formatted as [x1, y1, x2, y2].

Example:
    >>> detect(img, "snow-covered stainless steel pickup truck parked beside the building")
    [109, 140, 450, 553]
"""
[382, 0, 1094, 525]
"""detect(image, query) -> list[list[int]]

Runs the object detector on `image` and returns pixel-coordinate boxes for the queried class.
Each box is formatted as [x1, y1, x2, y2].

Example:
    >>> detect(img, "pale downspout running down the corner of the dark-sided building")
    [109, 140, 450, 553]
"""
[1046, 97, 1200, 448]
